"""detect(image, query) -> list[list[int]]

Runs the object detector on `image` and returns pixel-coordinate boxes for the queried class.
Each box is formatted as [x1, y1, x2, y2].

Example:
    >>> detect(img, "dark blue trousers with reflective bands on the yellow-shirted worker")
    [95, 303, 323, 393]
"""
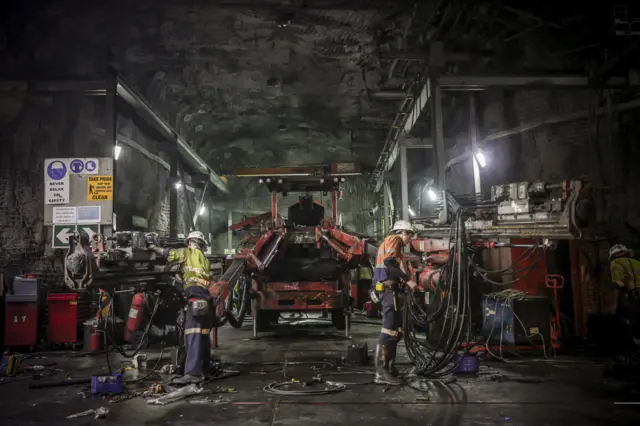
[184, 286, 213, 377]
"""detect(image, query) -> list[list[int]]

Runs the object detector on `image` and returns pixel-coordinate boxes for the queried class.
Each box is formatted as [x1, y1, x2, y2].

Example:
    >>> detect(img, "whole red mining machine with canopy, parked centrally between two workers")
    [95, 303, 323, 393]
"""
[220, 163, 375, 336]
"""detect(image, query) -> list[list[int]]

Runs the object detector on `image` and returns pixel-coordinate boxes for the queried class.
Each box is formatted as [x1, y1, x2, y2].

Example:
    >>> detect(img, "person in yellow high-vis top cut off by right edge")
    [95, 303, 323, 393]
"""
[609, 244, 640, 350]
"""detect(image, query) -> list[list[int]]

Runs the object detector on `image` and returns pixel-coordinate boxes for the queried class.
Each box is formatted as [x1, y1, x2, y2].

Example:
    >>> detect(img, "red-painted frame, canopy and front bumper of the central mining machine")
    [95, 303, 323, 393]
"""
[220, 163, 366, 322]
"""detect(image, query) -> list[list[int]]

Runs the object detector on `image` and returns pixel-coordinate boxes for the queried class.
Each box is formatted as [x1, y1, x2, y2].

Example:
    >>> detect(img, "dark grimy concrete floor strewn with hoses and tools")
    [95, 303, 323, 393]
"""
[0, 323, 640, 426]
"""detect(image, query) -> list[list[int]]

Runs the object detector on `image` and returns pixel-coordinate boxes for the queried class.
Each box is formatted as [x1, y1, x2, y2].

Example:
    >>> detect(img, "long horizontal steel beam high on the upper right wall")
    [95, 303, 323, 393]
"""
[440, 75, 638, 91]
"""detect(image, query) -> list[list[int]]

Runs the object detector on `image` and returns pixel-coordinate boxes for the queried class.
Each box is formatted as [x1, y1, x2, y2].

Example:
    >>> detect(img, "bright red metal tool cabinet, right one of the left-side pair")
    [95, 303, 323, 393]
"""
[47, 293, 90, 344]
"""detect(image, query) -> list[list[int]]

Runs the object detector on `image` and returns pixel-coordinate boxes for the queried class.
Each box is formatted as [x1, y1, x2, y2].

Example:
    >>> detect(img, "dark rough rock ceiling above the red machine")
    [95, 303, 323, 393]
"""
[0, 0, 616, 175]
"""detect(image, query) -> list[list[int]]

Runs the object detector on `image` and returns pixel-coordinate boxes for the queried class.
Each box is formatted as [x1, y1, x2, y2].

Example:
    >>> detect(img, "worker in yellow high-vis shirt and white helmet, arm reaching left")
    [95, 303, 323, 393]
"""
[147, 231, 218, 385]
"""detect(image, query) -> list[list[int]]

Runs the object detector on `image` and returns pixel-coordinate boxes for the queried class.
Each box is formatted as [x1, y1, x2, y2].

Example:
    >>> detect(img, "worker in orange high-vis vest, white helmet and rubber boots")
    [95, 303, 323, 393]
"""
[373, 220, 416, 386]
